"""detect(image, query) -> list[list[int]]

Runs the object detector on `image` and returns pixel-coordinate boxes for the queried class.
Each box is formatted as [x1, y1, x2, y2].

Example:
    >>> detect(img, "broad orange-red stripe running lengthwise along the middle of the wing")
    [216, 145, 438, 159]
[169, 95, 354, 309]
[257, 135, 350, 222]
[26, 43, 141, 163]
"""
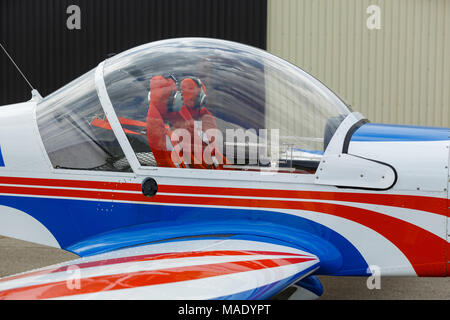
[0, 258, 314, 300]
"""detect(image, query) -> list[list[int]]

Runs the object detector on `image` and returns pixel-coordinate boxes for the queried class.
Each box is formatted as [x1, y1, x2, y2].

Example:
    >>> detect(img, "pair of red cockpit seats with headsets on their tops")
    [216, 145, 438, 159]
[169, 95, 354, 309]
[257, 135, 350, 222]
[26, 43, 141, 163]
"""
[147, 76, 227, 169]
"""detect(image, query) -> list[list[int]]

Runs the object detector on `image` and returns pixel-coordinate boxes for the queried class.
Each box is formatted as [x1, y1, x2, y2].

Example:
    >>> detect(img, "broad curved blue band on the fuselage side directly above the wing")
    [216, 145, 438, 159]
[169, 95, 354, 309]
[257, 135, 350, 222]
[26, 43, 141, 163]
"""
[0, 195, 367, 275]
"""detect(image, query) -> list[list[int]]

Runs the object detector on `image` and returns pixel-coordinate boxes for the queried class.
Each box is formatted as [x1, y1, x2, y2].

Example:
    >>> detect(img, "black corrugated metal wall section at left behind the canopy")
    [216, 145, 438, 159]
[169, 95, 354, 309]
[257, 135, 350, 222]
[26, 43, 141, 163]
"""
[0, 0, 267, 105]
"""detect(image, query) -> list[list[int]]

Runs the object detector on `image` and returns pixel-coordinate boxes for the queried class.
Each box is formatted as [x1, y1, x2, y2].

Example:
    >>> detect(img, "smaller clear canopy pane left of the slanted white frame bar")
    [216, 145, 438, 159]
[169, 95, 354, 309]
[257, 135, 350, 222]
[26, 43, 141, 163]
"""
[36, 70, 131, 172]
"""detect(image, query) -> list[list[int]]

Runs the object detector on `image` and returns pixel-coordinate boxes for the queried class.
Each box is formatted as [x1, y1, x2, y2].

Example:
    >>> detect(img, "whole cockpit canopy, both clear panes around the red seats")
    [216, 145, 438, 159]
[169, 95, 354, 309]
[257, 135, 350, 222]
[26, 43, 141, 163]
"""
[37, 38, 350, 173]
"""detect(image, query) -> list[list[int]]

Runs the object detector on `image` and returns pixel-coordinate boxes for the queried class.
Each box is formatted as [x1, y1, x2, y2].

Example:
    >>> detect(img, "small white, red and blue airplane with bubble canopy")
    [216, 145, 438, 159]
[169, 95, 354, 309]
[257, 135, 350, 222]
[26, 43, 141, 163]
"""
[0, 38, 450, 299]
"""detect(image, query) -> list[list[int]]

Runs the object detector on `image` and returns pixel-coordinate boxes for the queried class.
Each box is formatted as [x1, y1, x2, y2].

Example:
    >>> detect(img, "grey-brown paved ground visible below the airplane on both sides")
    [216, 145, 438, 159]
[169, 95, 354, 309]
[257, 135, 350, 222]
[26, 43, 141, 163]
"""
[0, 236, 450, 300]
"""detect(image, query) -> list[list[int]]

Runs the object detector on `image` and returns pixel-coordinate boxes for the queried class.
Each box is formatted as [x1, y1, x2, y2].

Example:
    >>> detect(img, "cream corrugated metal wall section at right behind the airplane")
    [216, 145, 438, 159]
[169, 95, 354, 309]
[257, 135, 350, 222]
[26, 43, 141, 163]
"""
[267, 0, 450, 127]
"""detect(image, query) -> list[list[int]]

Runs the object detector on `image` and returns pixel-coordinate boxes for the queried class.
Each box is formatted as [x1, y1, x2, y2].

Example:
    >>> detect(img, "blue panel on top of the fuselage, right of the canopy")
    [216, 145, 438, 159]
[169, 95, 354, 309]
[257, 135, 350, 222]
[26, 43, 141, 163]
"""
[351, 123, 450, 141]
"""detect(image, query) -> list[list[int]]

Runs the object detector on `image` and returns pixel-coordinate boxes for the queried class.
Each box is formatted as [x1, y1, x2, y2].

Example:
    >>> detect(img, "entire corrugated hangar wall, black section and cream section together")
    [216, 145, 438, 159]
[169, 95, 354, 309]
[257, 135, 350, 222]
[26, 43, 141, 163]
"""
[0, 0, 450, 127]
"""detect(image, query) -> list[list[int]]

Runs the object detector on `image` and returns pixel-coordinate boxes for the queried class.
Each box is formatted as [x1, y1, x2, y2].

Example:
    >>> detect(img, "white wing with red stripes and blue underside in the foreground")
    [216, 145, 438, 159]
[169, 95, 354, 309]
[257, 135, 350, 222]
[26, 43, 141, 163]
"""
[0, 239, 319, 300]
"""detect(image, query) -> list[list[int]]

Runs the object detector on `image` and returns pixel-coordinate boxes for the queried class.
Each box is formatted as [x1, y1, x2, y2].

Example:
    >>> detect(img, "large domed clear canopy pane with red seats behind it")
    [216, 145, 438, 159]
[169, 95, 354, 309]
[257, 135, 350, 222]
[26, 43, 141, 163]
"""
[104, 38, 350, 173]
